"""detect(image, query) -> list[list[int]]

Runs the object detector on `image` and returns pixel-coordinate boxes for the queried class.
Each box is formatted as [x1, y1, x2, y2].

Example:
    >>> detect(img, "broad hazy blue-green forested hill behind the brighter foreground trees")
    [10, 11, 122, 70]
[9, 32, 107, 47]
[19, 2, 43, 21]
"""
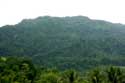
[0, 16, 125, 70]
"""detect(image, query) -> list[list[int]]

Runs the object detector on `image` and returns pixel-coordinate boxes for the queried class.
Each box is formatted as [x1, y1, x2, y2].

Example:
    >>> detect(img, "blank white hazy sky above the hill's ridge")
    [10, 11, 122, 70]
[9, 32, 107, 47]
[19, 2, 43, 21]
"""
[0, 0, 125, 26]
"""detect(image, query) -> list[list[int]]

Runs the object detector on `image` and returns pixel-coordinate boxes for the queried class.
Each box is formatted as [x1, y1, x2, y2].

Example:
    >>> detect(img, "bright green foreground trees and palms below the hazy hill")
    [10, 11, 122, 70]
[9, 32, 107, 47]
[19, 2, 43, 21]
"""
[0, 57, 125, 83]
